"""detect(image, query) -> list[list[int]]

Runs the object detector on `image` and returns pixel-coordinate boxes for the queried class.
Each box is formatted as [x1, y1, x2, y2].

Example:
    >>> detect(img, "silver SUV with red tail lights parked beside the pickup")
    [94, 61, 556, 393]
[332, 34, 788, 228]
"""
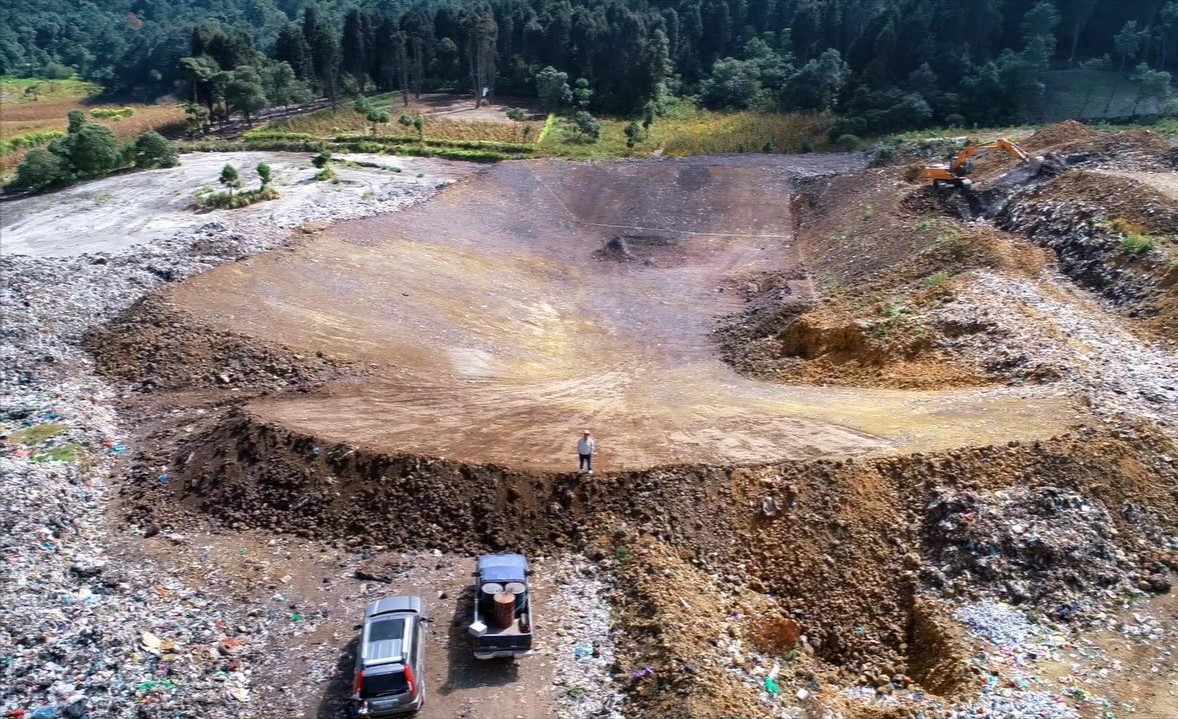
[349, 596, 430, 718]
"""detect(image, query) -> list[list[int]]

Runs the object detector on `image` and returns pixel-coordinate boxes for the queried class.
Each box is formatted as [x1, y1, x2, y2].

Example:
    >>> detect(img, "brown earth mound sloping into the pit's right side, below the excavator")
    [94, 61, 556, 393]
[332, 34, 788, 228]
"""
[716, 163, 1048, 389]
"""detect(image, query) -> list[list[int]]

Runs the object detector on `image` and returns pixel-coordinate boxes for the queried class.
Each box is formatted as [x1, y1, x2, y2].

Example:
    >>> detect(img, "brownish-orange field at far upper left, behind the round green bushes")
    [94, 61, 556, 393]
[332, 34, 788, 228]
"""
[0, 77, 184, 178]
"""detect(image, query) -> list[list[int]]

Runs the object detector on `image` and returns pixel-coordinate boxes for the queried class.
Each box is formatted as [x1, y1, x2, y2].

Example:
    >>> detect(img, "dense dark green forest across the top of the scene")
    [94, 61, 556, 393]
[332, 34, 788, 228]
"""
[0, 0, 1178, 132]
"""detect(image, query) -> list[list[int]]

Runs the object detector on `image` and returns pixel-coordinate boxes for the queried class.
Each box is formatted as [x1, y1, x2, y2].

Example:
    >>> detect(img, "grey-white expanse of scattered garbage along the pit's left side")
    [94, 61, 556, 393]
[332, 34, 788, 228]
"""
[0, 170, 457, 719]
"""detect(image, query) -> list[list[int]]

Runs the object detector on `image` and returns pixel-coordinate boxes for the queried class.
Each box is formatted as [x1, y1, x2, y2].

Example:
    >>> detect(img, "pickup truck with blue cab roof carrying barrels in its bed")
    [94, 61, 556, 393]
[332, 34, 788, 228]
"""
[469, 554, 534, 659]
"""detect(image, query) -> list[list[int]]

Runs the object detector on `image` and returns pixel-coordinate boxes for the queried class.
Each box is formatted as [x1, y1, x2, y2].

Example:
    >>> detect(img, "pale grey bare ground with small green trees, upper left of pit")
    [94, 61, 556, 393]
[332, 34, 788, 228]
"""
[0, 152, 474, 257]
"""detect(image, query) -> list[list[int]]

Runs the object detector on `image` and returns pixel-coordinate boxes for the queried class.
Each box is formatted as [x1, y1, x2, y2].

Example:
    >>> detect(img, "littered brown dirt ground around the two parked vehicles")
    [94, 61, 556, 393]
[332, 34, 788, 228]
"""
[125, 527, 574, 719]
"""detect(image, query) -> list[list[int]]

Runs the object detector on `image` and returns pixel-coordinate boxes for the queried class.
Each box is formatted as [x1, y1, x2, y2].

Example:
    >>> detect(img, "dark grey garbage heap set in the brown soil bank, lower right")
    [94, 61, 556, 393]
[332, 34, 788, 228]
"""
[921, 487, 1170, 612]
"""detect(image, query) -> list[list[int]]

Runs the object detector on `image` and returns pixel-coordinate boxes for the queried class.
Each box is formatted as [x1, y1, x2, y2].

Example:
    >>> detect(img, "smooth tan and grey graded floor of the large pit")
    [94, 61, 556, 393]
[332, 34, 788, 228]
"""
[165, 157, 1073, 470]
